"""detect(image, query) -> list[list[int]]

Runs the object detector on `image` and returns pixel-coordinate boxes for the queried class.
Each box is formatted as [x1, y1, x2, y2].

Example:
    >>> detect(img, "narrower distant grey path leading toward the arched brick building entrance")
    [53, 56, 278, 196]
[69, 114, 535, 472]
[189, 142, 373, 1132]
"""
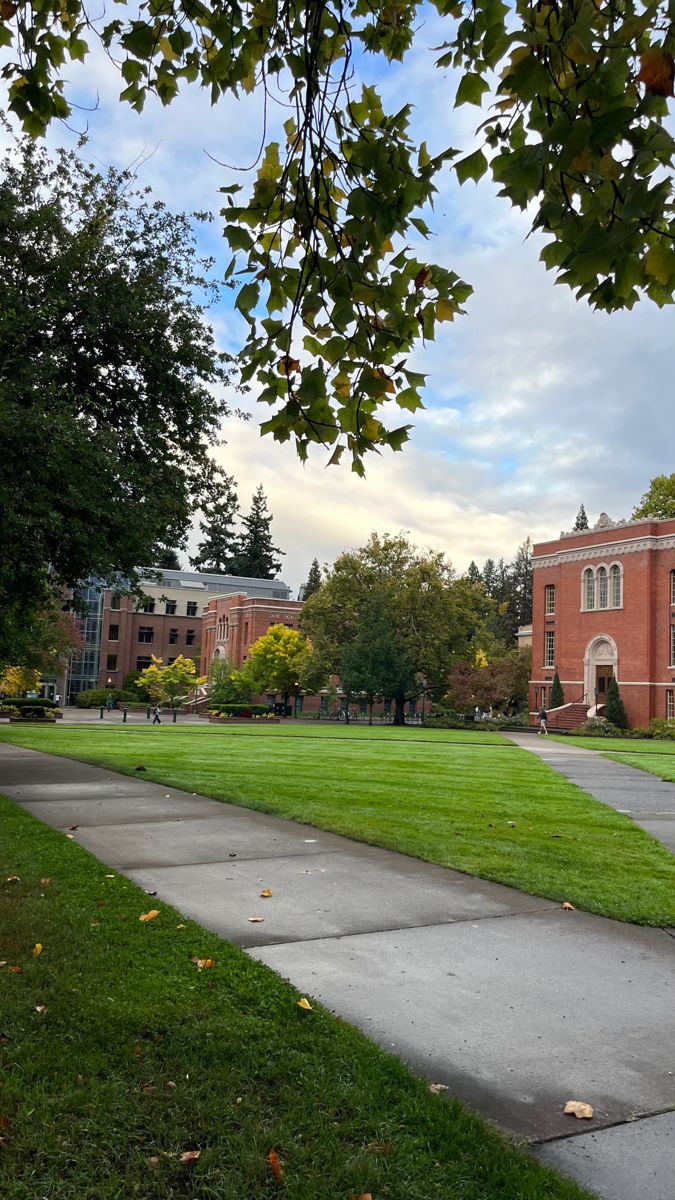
[504, 733, 675, 854]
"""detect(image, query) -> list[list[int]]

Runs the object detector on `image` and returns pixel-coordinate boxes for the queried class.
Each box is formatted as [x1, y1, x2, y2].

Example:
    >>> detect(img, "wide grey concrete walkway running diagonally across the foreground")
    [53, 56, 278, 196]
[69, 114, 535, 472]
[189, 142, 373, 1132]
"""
[0, 744, 675, 1200]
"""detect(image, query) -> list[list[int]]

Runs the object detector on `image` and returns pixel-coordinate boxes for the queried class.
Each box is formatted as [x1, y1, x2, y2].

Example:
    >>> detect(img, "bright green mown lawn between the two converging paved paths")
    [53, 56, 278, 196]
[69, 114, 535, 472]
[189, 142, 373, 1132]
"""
[0, 725, 675, 925]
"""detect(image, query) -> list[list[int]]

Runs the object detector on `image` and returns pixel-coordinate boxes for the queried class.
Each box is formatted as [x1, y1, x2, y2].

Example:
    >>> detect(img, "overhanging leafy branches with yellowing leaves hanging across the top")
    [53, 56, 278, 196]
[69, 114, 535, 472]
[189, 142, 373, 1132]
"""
[0, 0, 675, 473]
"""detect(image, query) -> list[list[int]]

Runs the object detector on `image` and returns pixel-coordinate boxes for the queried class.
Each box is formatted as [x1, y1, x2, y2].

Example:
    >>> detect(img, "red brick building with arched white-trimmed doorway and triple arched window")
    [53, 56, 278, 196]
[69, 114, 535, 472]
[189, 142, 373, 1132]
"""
[530, 512, 675, 725]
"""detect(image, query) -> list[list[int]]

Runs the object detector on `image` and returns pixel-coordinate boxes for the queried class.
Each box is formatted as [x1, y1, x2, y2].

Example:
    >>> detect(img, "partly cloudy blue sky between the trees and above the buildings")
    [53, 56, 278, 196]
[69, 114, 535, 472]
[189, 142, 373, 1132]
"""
[9, 9, 675, 588]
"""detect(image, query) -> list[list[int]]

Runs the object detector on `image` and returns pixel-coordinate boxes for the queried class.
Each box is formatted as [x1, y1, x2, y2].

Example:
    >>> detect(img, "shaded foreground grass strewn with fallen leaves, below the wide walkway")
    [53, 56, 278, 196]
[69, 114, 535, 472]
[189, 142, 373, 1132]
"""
[0, 797, 590, 1200]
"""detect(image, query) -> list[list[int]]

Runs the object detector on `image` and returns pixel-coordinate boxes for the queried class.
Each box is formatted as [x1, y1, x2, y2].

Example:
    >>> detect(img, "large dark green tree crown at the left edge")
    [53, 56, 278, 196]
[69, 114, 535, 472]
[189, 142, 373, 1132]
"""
[0, 139, 228, 661]
